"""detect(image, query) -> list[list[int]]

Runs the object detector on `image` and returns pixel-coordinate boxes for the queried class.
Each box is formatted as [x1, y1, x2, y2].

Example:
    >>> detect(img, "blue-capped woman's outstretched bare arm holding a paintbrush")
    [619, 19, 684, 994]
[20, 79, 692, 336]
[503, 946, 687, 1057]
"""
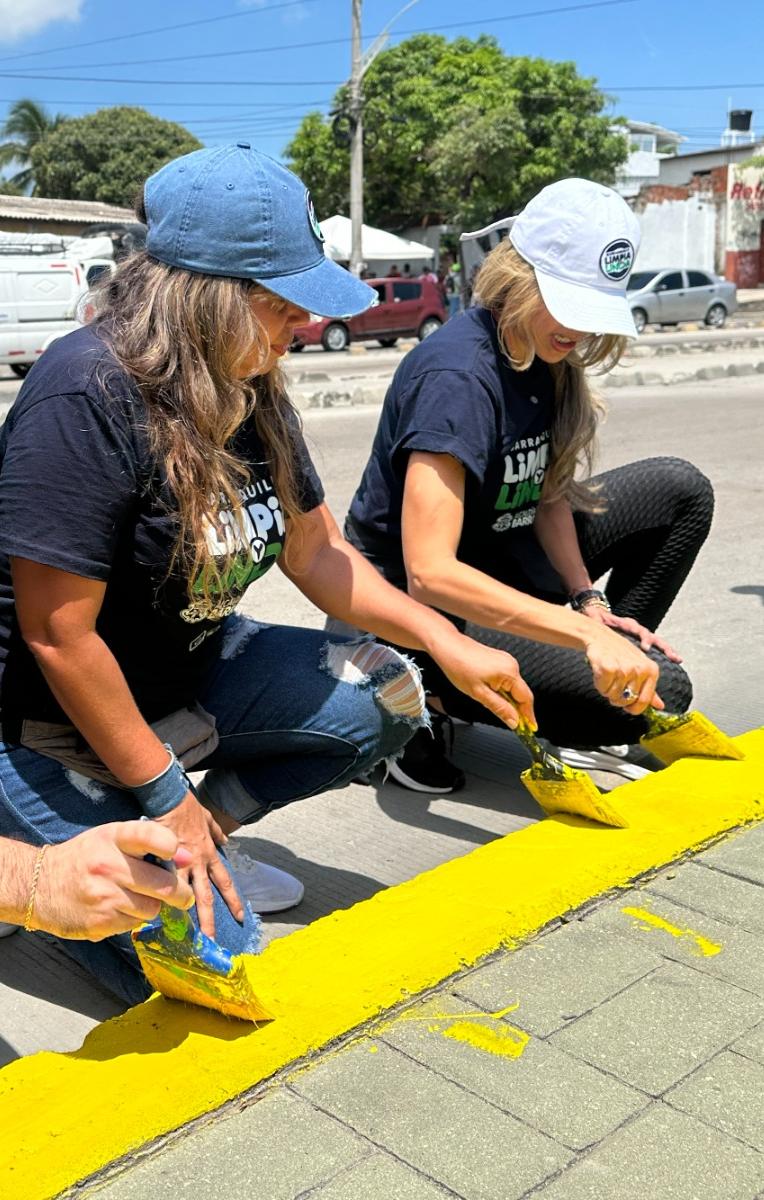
[279, 504, 536, 727]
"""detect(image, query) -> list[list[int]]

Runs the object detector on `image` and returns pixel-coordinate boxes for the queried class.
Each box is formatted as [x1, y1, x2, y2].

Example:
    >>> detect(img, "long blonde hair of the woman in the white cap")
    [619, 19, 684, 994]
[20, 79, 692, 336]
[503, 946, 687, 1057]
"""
[475, 239, 626, 512]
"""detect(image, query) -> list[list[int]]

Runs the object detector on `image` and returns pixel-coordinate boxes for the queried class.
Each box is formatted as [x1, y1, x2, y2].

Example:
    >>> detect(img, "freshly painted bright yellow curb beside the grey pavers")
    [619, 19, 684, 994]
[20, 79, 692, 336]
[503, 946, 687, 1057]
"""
[0, 730, 764, 1200]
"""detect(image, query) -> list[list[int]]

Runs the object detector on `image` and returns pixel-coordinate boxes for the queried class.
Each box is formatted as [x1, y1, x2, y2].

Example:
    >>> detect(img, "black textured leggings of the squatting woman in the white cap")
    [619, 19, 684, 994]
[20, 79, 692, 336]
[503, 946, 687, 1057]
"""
[398, 458, 714, 748]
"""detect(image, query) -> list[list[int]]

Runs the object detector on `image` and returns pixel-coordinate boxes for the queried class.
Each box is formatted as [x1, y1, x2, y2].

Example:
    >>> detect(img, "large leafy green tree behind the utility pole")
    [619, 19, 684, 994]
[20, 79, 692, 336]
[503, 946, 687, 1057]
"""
[285, 34, 627, 226]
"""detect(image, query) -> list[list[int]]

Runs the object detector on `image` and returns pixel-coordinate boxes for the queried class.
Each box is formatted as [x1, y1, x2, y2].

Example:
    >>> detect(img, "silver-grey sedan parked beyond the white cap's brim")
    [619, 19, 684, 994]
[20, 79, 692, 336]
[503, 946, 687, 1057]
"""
[628, 268, 738, 334]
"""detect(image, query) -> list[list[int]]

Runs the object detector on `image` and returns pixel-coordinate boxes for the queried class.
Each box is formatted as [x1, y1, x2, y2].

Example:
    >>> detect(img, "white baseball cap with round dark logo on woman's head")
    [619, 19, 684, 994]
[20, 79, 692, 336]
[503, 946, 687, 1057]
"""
[462, 179, 639, 337]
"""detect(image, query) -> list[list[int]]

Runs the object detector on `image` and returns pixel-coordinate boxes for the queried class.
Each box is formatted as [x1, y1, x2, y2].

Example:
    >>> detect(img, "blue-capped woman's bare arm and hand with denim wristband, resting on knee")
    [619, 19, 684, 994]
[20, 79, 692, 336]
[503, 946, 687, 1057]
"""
[11, 558, 243, 936]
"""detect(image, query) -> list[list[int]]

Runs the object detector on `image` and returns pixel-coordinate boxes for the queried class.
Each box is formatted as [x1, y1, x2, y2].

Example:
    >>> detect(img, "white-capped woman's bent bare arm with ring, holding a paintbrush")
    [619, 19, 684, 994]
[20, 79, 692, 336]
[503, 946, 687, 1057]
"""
[402, 451, 662, 714]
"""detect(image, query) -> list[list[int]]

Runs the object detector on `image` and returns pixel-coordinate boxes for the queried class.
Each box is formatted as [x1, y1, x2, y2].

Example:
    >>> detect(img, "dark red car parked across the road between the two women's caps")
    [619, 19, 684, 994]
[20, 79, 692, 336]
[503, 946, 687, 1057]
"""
[291, 278, 449, 350]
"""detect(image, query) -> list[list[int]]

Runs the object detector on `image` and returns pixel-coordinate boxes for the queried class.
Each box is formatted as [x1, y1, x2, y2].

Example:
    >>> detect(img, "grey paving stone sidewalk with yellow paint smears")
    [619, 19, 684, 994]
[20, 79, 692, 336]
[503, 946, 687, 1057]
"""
[85, 826, 764, 1200]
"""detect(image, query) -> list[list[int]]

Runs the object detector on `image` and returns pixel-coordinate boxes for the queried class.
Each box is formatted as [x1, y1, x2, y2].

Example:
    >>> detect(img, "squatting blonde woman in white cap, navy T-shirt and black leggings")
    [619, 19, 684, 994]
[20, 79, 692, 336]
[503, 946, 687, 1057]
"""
[345, 179, 714, 792]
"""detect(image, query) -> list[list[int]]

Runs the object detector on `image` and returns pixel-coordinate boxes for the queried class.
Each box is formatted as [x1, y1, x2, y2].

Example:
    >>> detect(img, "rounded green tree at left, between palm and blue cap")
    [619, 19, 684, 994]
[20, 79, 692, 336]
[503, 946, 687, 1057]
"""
[31, 108, 200, 204]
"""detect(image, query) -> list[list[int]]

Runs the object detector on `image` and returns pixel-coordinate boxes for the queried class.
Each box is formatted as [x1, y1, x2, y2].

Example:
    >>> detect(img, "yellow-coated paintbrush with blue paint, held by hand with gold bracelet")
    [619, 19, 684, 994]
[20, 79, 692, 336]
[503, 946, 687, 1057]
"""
[132, 859, 272, 1021]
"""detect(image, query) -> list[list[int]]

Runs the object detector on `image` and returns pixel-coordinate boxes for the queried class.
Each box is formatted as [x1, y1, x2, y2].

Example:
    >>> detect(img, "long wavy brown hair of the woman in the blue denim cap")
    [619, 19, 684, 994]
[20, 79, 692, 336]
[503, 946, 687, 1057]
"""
[96, 242, 300, 608]
